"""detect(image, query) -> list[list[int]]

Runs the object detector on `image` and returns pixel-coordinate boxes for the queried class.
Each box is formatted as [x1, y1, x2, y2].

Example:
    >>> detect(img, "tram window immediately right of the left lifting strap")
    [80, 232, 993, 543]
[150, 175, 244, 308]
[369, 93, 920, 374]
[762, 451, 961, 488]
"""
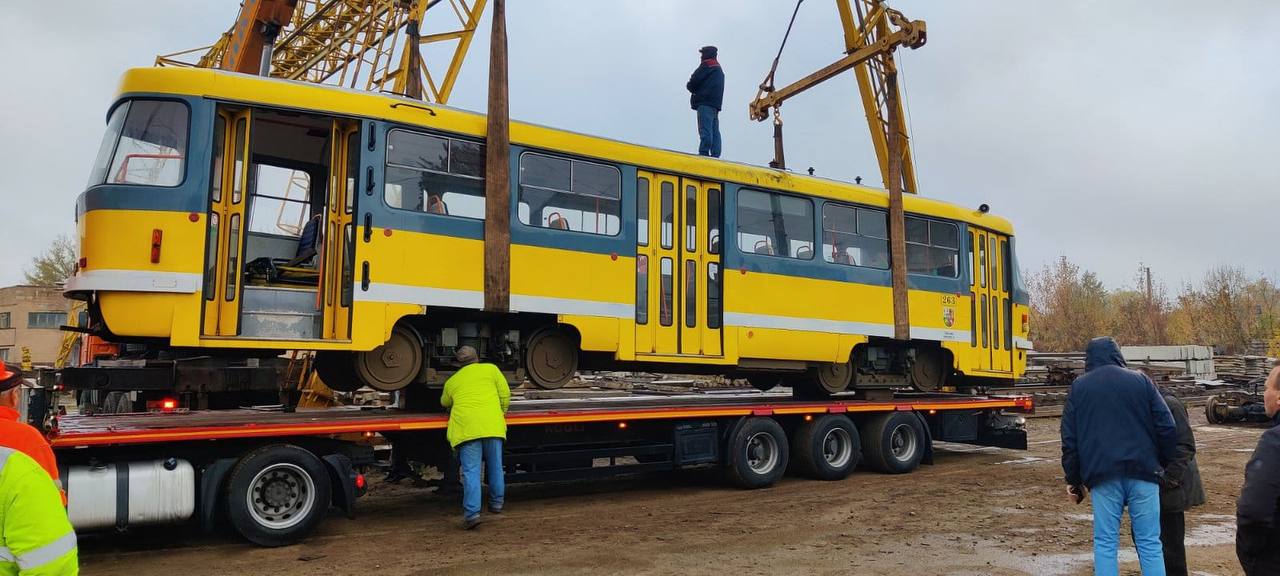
[516, 152, 622, 236]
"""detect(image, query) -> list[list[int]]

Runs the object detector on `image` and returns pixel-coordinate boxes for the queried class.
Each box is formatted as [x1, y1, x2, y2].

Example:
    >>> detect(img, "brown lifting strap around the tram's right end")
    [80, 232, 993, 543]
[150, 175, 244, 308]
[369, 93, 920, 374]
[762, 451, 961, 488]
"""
[884, 70, 911, 340]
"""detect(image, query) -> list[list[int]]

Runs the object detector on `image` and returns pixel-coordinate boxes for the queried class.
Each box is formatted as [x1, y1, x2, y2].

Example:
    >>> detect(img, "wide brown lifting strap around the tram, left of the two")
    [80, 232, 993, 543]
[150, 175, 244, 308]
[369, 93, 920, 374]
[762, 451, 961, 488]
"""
[481, 0, 511, 312]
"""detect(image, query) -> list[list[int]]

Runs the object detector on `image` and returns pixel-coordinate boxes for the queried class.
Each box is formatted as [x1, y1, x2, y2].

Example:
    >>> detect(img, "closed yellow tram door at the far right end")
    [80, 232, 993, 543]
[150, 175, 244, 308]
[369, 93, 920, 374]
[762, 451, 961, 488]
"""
[969, 229, 1012, 372]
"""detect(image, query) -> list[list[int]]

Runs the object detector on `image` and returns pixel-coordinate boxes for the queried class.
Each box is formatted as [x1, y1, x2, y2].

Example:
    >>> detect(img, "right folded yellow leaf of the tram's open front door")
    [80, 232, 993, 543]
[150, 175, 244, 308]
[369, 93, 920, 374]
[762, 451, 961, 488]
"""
[320, 120, 360, 339]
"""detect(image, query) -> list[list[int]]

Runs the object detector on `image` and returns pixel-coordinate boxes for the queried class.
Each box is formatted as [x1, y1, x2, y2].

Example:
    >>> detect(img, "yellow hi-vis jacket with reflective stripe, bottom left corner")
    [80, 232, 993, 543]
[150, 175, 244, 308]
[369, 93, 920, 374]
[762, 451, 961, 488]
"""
[0, 448, 79, 576]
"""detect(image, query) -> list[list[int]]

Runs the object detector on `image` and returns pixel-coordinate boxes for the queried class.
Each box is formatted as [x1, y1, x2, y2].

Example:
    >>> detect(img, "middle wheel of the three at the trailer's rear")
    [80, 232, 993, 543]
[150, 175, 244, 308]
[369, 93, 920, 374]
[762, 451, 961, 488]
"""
[791, 413, 863, 480]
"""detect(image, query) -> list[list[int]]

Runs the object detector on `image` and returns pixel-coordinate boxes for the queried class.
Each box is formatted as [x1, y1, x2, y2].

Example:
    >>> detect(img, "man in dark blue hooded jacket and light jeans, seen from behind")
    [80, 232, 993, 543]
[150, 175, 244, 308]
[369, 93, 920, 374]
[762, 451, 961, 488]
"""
[1062, 338, 1178, 576]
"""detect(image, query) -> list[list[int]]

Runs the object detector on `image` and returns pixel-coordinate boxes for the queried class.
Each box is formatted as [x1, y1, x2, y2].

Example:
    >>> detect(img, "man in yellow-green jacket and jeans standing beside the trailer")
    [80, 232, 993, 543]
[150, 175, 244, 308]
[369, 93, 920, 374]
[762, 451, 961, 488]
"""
[440, 346, 511, 530]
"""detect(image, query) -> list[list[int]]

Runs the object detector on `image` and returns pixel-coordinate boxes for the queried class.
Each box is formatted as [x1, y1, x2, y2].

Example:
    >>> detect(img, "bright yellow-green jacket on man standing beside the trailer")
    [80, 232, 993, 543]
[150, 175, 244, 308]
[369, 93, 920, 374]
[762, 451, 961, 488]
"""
[440, 362, 511, 448]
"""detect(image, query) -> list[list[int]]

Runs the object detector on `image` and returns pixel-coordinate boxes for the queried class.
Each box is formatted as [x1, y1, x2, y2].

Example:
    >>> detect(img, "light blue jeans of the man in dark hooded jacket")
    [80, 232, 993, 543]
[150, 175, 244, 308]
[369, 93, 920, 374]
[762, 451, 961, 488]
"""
[1091, 479, 1165, 576]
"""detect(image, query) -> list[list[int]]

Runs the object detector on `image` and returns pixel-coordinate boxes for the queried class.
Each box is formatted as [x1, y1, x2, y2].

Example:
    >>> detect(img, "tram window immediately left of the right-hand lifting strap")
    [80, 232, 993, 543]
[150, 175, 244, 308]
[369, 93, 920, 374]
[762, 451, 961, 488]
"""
[822, 202, 888, 270]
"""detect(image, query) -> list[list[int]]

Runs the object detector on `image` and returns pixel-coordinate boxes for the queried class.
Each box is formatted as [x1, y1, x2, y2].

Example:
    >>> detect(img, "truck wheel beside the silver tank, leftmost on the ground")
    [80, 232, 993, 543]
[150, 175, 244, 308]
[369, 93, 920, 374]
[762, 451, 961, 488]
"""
[227, 444, 333, 547]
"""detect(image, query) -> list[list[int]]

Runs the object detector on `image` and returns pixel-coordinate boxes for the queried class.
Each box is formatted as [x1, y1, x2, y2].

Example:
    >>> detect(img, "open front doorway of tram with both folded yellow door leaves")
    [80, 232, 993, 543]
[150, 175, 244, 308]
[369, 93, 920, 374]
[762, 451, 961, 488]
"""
[202, 108, 358, 340]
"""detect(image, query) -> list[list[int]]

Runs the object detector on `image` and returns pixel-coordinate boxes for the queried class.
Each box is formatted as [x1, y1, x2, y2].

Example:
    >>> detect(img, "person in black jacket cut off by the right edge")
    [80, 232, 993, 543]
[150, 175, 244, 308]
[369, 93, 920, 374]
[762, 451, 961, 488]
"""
[1235, 366, 1280, 576]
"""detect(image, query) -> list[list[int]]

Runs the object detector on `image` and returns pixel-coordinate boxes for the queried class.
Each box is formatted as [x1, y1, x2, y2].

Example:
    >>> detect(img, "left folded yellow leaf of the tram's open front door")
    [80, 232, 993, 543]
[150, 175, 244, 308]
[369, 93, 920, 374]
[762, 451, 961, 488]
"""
[201, 109, 252, 337]
